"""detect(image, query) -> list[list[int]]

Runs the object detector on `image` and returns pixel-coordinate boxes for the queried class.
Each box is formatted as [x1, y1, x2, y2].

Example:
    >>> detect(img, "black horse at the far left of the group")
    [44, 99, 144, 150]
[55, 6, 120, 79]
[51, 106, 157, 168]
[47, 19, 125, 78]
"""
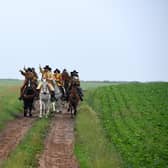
[22, 80, 36, 117]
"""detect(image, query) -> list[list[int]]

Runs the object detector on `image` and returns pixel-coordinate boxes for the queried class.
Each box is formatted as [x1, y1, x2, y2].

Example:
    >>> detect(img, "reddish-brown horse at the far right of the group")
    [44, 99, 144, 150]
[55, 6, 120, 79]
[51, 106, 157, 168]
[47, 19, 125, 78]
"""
[68, 86, 80, 118]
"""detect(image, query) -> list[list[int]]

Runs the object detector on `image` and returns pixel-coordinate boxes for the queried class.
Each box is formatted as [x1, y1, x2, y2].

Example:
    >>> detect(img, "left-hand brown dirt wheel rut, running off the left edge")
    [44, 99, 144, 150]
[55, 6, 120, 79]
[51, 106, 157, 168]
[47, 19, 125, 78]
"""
[0, 113, 36, 165]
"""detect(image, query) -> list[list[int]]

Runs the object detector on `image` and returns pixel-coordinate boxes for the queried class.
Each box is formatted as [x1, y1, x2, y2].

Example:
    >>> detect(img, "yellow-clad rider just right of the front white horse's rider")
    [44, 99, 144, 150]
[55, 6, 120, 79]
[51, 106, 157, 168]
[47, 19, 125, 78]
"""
[53, 68, 65, 97]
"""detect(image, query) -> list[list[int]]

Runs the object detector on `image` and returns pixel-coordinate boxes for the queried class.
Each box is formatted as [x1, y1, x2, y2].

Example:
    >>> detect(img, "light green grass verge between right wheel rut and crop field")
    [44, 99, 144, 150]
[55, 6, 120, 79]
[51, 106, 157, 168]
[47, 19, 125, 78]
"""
[75, 104, 122, 168]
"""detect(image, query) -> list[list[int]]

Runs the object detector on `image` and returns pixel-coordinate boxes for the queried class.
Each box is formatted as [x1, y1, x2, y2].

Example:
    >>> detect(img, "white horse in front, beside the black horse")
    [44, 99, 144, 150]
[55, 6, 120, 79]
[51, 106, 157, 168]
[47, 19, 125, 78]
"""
[39, 80, 51, 118]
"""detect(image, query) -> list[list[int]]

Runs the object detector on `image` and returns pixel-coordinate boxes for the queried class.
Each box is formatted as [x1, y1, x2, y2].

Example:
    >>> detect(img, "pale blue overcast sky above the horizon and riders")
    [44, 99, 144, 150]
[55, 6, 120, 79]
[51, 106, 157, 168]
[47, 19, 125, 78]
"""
[0, 0, 168, 82]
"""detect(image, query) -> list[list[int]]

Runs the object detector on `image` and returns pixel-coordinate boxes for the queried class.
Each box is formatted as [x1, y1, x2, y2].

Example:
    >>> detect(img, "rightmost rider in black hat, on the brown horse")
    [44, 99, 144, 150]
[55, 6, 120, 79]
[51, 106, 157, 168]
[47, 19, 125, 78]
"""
[70, 70, 83, 101]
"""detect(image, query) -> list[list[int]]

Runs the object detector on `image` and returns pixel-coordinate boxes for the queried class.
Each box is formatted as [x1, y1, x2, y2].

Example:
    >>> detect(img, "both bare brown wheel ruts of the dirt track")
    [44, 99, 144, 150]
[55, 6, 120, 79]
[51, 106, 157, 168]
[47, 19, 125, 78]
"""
[0, 103, 79, 168]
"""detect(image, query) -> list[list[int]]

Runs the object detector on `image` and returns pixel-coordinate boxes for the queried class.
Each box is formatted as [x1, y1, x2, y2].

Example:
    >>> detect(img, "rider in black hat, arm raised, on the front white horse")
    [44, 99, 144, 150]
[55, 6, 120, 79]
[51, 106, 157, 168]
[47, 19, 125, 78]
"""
[37, 65, 55, 101]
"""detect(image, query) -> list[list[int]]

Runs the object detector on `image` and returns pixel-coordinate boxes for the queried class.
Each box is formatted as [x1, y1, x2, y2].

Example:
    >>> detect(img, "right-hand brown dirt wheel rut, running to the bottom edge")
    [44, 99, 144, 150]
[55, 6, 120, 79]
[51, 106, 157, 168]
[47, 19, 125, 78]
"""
[39, 107, 79, 168]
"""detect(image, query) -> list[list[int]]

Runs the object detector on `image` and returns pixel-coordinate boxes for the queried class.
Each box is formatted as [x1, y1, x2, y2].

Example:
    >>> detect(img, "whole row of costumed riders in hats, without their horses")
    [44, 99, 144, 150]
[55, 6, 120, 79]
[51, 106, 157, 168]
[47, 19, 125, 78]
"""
[19, 65, 83, 101]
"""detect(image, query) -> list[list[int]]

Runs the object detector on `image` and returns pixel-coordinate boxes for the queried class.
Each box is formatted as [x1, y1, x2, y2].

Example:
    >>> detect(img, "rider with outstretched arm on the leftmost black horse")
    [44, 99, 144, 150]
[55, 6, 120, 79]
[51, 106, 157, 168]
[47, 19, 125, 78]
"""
[19, 67, 34, 100]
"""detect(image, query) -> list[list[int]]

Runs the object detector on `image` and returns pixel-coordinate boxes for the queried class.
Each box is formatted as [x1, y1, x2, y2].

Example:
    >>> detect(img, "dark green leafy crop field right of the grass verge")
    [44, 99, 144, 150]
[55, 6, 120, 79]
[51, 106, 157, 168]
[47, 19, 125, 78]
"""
[77, 83, 168, 168]
